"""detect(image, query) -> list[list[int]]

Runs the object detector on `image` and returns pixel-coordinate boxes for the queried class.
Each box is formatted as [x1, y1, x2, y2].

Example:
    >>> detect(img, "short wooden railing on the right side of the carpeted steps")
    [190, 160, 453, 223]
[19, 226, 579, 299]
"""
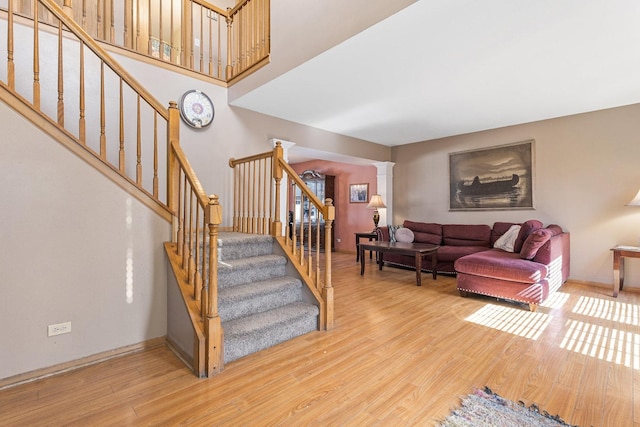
[229, 142, 335, 330]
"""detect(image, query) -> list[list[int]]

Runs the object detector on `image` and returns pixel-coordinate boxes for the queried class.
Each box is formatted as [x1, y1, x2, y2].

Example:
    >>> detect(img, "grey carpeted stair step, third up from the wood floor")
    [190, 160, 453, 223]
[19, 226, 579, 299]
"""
[218, 255, 287, 289]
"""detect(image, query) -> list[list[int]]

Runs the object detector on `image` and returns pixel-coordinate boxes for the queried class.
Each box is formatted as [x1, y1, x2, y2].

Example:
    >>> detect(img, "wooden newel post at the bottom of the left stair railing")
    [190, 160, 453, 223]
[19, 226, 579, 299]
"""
[208, 195, 224, 377]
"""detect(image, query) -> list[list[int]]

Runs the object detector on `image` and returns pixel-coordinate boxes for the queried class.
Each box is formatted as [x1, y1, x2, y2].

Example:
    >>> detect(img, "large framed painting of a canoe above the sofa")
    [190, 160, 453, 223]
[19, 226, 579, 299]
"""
[449, 140, 535, 211]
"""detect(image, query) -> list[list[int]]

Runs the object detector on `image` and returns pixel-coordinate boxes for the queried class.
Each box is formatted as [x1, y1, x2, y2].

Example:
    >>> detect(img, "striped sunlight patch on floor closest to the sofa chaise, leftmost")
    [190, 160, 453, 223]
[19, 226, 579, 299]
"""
[465, 304, 551, 340]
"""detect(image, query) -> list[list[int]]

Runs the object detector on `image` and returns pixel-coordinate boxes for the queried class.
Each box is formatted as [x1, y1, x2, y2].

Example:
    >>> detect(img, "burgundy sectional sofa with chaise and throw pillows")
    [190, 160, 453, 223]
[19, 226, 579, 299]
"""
[376, 220, 570, 311]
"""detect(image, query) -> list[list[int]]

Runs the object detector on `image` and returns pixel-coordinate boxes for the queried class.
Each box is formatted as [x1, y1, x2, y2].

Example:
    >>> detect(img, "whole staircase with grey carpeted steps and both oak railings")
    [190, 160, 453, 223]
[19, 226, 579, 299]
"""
[0, 0, 335, 377]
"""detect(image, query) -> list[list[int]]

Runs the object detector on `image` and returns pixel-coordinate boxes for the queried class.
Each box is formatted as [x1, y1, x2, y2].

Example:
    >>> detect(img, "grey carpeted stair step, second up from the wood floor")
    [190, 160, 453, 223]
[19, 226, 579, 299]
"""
[218, 276, 302, 321]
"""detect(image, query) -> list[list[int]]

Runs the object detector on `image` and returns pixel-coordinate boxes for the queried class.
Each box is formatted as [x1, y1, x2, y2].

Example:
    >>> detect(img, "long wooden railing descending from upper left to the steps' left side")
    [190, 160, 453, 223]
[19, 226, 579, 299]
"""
[0, 0, 223, 376]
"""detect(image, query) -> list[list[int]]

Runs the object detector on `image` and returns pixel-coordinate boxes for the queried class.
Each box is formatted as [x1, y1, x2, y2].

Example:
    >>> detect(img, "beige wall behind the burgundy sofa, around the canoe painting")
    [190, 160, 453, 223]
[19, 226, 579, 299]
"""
[392, 105, 640, 287]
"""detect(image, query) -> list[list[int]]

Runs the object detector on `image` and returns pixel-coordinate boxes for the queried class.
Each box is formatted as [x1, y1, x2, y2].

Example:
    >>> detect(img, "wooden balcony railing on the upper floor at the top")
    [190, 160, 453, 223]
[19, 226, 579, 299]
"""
[9, 0, 270, 84]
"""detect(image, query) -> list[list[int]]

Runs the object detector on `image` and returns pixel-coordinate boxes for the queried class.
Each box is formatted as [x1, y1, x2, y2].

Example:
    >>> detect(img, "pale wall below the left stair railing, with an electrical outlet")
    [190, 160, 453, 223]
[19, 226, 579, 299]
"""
[0, 103, 170, 378]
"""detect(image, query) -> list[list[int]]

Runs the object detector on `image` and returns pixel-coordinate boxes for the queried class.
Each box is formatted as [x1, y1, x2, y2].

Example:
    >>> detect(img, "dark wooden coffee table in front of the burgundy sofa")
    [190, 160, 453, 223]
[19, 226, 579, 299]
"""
[358, 242, 440, 286]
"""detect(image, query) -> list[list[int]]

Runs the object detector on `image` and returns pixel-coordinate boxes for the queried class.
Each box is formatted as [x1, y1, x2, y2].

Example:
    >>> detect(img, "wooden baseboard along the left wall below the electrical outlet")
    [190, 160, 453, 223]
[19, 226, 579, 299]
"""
[0, 337, 166, 390]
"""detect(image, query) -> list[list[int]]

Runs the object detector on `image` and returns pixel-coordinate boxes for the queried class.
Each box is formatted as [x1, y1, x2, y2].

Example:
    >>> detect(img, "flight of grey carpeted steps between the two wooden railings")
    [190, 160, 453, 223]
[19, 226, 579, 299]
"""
[218, 232, 319, 363]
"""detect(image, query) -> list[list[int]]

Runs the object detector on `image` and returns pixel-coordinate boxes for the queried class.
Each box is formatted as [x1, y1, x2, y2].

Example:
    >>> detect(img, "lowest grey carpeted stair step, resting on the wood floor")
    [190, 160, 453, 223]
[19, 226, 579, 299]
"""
[222, 302, 319, 363]
